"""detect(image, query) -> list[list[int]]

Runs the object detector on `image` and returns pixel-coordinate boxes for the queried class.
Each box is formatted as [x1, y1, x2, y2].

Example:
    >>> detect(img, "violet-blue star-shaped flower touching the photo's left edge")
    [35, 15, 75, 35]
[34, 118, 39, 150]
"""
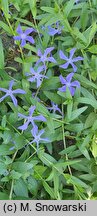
[0, 80, 26, 106]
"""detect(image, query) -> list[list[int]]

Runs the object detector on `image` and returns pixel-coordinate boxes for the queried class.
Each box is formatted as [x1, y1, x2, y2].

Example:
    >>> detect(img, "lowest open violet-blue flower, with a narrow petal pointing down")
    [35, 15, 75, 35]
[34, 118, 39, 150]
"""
[30, 128, 49, 150]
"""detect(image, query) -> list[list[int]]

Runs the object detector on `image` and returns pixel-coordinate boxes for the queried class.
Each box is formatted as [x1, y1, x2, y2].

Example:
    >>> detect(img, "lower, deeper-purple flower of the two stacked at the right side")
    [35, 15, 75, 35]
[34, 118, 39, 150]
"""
[58, 73, 80, 96]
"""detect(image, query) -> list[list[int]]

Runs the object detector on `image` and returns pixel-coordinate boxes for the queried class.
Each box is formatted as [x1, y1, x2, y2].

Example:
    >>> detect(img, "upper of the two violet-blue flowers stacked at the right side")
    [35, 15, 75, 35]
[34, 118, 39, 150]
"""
[59, 48, 83, 72]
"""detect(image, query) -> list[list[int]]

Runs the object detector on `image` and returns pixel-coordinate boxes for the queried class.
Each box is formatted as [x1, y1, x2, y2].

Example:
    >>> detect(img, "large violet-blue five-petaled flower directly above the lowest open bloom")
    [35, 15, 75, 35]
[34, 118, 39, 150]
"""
[18, 106, 46, 131]
